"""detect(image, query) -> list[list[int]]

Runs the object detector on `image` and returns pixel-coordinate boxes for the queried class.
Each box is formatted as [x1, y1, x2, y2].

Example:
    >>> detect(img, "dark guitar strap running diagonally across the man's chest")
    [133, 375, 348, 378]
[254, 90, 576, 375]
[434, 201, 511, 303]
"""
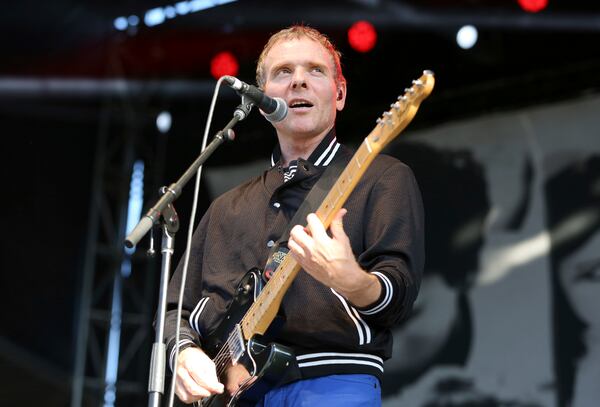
[263, 154, 351, 281]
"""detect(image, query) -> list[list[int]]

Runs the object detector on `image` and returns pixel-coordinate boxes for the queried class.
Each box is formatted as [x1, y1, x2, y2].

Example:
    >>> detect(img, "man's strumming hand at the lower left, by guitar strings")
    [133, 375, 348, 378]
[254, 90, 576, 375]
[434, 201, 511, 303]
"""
[175, 347, 224, 403]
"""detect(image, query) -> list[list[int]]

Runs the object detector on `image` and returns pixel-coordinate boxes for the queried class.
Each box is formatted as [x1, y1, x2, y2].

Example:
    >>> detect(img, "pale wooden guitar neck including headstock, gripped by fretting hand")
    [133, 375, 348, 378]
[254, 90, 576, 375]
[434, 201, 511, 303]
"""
[240, 71, 434, 340]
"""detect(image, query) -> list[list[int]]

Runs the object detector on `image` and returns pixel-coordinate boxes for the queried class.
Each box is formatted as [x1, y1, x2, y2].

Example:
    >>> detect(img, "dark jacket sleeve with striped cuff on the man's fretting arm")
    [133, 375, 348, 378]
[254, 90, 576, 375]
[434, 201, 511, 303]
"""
[357, 161, 425, 327]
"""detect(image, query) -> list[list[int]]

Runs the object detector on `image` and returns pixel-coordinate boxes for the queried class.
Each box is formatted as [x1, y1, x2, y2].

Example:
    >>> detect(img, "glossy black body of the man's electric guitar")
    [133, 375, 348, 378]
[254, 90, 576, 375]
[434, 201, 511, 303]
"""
[199, 269, 295, 407]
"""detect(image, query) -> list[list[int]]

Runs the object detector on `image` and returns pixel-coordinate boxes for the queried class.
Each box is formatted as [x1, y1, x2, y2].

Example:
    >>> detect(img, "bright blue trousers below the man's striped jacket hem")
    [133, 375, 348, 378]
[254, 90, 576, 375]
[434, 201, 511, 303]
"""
[256, 374, 381, 407]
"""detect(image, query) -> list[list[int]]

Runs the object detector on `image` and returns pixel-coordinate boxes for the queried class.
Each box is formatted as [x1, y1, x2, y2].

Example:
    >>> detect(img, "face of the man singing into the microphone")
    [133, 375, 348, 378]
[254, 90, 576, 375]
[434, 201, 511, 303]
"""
[264, 38, 346, 140]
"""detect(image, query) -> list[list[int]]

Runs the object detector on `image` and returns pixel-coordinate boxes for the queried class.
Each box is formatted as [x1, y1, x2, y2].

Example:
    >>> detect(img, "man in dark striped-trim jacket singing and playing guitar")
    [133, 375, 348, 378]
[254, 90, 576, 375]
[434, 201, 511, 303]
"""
[166, 26, 423, 407]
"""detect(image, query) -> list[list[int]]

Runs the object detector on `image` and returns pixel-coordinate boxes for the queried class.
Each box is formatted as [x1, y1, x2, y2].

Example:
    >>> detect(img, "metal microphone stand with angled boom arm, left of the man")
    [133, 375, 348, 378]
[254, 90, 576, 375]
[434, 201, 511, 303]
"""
[125, 96, 254, 407]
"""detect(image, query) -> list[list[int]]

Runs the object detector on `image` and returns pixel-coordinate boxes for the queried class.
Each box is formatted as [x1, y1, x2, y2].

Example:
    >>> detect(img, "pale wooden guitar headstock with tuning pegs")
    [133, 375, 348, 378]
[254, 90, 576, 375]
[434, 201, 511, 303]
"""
[367, 70, 435, 151]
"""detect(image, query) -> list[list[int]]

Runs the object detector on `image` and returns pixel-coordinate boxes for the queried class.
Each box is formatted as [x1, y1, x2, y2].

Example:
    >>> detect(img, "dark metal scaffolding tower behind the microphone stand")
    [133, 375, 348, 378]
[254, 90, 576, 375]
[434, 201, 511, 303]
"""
[71, 74, 166, 407]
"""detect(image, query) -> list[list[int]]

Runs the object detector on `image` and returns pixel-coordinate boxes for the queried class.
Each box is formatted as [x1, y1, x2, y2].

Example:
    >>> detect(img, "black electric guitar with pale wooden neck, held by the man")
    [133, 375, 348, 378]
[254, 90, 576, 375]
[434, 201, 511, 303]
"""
[198, 71, 435, 407]
